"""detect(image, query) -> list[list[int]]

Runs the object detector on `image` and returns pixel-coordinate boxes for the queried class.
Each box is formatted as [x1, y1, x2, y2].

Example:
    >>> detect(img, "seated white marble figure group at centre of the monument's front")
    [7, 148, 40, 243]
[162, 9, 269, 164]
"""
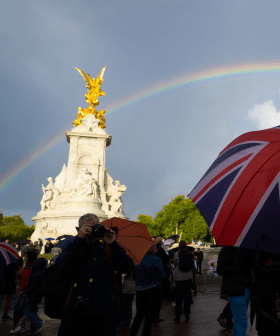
[70, 168, 99, 198]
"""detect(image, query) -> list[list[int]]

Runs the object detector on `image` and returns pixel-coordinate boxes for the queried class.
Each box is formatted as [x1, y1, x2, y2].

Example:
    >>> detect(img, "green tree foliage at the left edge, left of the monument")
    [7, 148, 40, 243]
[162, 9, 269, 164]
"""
[0, 212, 35, 242]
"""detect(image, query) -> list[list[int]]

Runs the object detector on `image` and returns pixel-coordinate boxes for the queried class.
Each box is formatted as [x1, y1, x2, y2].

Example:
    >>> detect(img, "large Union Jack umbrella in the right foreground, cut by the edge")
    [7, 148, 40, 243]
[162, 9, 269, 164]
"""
[189, 126, 280, 249]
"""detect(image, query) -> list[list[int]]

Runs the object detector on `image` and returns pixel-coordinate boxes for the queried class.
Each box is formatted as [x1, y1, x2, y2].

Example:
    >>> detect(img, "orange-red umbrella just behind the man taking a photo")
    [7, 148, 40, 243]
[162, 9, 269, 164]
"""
[101, 217, 154, 265]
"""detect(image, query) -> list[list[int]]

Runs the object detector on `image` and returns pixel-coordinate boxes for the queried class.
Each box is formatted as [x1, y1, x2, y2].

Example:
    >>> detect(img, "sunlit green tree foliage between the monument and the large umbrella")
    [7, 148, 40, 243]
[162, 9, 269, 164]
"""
[137, 195, 214, 243]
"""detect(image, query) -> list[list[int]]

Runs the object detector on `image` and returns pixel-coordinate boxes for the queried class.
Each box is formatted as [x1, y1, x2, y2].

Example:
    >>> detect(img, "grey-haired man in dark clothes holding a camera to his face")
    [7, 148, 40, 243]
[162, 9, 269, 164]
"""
[55, 214, 133, 336]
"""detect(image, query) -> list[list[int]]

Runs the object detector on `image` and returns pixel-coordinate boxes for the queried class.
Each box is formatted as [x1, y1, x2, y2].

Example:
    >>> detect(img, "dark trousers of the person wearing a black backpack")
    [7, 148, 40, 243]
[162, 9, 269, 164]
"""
[175, 280, 192, 316]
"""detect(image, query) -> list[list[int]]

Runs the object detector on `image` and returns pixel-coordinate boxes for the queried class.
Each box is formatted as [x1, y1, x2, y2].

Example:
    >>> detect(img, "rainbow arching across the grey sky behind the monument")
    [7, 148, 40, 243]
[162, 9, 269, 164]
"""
[0, 61, 280, 193]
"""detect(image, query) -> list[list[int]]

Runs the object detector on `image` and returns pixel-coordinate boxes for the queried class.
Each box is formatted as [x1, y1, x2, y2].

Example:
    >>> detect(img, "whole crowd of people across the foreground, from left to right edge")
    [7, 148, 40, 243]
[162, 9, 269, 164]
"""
[0, 214, 280, 336]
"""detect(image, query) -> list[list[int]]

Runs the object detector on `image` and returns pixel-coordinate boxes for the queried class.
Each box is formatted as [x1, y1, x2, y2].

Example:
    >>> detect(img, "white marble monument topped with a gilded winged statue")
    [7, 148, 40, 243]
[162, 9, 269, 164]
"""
[31, 67, 126, 241]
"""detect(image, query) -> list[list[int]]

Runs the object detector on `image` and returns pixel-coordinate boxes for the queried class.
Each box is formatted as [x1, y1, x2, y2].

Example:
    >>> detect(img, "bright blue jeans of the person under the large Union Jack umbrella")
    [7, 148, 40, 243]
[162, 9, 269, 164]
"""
[227, 288, 250, 336]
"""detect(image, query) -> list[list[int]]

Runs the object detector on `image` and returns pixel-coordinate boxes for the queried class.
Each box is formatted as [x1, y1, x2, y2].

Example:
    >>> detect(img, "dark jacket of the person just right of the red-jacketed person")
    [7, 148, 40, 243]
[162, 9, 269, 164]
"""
[22, 258, 47, 303]
